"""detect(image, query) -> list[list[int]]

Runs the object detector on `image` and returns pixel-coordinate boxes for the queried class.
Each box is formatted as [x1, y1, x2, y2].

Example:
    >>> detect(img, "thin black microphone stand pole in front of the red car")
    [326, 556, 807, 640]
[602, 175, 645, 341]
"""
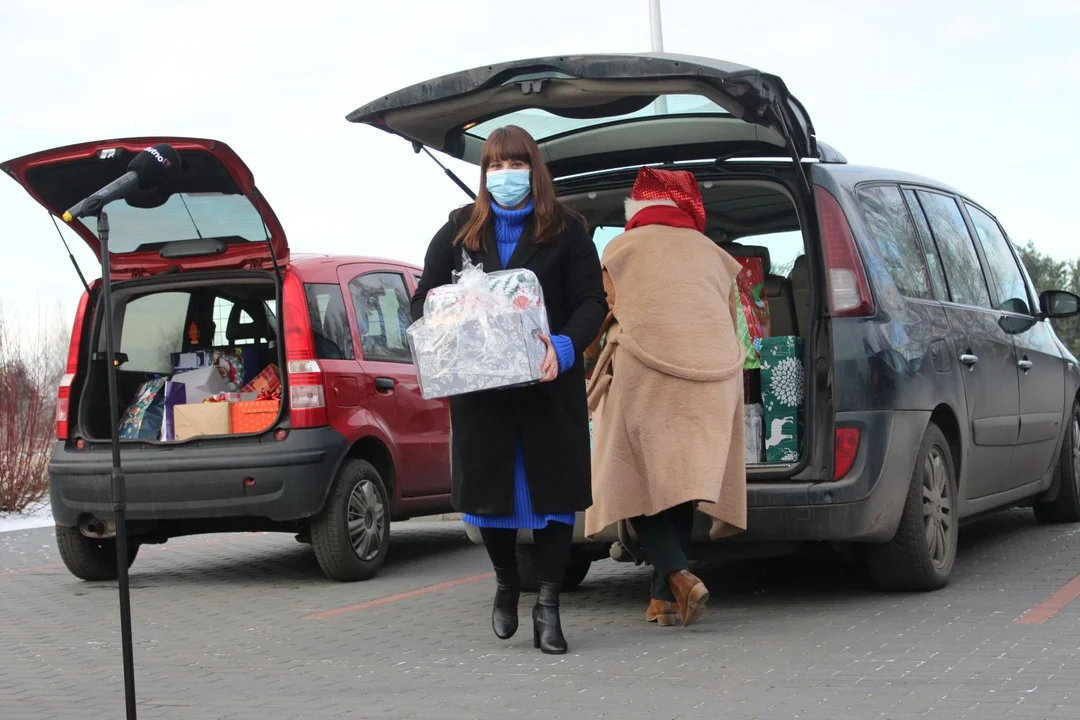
[97, 210, 135, 720]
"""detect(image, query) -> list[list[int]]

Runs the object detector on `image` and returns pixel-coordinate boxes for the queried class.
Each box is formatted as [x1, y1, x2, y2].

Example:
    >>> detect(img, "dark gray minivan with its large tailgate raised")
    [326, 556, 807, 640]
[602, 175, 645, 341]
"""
[349, 54, 1080, 589]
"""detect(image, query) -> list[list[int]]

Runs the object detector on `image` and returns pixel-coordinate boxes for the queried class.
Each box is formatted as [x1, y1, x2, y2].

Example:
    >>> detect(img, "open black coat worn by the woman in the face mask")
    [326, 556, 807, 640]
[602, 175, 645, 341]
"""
[411, 206, 607, 515]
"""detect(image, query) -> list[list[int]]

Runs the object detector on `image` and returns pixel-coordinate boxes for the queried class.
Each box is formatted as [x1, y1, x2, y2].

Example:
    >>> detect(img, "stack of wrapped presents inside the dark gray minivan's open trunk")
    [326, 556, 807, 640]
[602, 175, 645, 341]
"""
[735, 257, 805, 464]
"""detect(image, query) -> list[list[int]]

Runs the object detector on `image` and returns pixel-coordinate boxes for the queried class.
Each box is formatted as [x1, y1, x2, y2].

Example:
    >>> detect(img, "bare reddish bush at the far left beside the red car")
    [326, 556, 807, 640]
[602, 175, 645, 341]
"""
[0, 306, 69, 513]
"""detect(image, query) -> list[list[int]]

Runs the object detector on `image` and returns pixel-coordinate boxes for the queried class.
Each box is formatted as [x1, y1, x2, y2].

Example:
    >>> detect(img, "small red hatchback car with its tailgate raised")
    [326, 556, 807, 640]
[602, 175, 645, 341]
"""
[0, 137, 450, 581]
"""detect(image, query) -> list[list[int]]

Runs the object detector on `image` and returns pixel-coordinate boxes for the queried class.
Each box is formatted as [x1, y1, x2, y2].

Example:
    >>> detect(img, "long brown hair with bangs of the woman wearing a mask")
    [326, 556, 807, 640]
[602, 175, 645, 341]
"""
[454, 125, 570, 253]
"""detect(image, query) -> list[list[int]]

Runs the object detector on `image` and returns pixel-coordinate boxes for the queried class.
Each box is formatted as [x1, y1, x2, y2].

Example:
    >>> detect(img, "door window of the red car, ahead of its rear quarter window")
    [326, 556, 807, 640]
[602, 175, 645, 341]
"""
[349, 272, 413, 363]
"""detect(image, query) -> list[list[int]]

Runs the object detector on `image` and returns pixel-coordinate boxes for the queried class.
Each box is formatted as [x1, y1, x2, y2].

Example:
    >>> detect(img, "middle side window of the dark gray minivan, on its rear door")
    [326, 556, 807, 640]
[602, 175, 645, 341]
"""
[912, 190, 993, 309]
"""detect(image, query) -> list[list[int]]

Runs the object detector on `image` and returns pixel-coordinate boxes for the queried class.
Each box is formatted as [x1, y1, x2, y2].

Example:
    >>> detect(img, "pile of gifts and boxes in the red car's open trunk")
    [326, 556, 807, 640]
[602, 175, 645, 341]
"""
[120, 345, 281, 441]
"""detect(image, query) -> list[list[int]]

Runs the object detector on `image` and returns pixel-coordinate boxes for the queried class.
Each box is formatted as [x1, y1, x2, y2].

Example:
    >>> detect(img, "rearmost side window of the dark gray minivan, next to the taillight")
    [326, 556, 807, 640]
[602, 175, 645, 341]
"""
[859, 185, 933, 300]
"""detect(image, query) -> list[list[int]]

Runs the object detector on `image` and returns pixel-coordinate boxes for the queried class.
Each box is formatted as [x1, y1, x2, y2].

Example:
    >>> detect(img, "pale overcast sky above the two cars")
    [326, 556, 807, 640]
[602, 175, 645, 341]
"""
[0, 0, 1080, 341]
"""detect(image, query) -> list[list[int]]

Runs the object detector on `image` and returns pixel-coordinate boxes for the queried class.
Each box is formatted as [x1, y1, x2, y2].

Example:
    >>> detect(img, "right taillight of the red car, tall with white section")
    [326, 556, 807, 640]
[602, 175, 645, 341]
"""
[282, 272, 328, 427]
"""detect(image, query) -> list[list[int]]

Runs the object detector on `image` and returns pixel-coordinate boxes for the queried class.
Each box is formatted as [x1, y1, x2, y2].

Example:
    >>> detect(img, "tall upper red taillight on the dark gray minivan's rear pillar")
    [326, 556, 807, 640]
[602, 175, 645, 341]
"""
[814, 185, 874, 317]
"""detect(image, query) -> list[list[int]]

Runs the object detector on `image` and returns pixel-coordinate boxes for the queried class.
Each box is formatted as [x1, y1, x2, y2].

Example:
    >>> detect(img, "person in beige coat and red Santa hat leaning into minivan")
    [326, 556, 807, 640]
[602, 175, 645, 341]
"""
[585, 167, 746, 625]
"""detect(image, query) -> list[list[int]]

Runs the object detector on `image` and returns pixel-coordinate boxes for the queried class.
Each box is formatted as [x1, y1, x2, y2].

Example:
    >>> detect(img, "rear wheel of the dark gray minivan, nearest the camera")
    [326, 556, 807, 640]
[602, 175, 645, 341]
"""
[865, 423, 959, 590]
